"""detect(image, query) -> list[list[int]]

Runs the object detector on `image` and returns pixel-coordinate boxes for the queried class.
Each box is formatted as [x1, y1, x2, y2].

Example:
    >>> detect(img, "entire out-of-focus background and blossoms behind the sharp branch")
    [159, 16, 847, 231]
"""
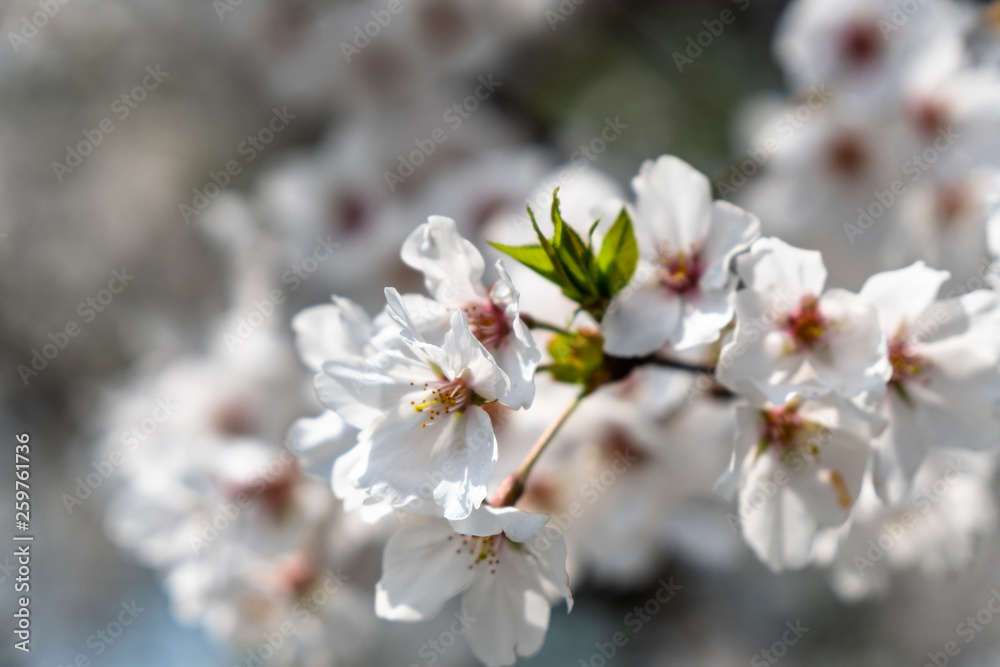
[0, 0, 1000, 667]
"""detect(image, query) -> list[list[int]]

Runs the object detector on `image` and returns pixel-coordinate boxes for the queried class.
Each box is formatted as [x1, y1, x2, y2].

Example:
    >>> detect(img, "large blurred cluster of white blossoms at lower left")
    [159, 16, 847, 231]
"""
[100, 320, 378, 666]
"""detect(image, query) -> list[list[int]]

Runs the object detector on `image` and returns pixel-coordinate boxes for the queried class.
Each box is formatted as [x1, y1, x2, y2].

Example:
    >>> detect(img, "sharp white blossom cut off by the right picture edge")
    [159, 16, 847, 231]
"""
[861, 262, 1000, 503]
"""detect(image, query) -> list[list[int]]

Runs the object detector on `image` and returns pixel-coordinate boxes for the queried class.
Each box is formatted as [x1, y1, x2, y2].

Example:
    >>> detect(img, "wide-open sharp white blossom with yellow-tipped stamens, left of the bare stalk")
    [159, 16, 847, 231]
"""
[316, 311, 510, 519]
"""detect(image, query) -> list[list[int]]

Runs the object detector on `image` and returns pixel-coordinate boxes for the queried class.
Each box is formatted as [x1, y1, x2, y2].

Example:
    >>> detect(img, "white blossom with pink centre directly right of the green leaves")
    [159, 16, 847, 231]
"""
[601, 156, 760, 357]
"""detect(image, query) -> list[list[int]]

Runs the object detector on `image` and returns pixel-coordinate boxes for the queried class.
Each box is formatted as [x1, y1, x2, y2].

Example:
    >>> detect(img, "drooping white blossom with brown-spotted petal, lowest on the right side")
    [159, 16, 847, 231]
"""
[717, 395, 884, 571]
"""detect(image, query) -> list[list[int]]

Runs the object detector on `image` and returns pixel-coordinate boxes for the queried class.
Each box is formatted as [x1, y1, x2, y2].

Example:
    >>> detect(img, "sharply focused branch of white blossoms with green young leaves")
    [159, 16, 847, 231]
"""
[295, 146, 1000, 665]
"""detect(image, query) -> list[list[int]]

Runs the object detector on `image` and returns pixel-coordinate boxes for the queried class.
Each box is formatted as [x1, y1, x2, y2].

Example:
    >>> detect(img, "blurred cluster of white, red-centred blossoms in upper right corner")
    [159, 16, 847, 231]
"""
[736, 0, 1000, 294]
